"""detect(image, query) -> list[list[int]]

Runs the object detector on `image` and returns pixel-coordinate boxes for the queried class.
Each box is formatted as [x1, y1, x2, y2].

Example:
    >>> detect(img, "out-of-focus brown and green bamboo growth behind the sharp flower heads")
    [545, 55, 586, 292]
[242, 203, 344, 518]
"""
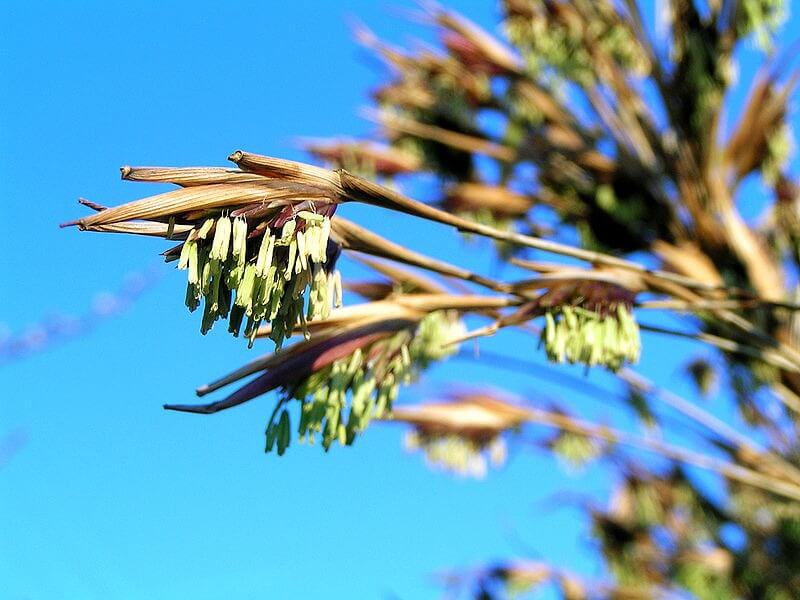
[296, 0, 800, 600]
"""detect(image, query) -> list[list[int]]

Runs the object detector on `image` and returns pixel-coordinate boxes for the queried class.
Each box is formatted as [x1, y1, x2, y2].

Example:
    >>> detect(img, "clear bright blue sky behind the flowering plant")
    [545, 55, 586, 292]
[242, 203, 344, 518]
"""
[0, 0, 796, 600]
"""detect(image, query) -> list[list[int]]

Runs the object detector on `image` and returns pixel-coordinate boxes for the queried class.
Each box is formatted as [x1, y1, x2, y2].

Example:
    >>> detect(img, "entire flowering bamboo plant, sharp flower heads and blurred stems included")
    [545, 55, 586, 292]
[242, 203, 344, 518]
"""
[65, 0, 800, 599]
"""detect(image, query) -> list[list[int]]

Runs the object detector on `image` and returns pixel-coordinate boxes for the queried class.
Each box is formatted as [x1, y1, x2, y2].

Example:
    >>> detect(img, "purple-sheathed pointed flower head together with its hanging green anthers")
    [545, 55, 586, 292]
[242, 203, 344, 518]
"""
[170, 305, 468, 454]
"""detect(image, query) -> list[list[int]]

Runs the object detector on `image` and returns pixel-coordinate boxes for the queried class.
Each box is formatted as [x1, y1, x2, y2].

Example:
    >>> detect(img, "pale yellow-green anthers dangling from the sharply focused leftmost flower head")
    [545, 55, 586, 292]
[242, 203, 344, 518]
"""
[178, 211, 341, 347]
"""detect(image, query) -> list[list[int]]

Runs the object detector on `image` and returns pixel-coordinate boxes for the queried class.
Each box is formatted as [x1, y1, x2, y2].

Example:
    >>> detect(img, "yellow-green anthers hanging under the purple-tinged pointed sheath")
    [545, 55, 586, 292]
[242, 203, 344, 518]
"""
[266, 311, 463, 454]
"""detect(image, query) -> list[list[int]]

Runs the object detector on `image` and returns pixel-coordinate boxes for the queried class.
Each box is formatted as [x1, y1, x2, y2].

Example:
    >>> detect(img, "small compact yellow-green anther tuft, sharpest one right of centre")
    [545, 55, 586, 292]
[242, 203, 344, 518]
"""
[541, 303, 641, 371]
